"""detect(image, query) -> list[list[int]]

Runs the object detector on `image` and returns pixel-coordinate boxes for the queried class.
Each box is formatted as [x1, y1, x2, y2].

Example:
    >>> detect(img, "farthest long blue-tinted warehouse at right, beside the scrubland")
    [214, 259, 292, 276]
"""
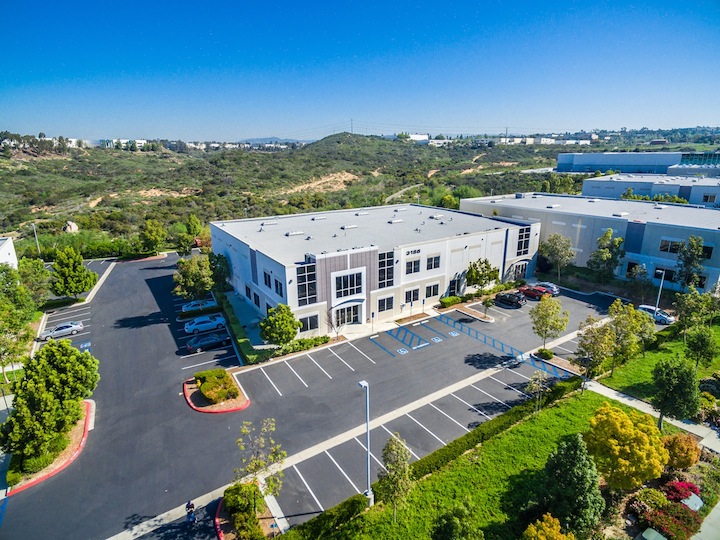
[557, 152, 720, 176]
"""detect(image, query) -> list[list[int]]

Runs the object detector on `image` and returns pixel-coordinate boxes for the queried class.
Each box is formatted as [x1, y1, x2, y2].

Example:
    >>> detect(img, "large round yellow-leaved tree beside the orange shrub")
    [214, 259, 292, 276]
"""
[584, 403, 669, 490]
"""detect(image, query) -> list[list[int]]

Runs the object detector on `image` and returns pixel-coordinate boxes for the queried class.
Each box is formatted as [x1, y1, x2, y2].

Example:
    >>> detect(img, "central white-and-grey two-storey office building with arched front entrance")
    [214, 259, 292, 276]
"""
[210, 205, 539, 336]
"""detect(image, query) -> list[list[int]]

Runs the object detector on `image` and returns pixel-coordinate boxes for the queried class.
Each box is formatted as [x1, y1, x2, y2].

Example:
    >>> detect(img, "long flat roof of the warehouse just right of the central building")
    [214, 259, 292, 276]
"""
[461, 193, 720, 231]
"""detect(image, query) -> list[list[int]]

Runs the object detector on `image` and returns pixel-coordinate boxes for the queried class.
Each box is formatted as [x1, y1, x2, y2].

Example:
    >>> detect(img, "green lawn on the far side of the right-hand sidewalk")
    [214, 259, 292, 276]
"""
[601, 325, 720, 401]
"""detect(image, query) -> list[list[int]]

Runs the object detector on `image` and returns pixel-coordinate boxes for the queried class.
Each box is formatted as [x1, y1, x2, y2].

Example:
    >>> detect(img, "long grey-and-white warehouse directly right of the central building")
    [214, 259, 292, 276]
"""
[460, 193, 720, 290]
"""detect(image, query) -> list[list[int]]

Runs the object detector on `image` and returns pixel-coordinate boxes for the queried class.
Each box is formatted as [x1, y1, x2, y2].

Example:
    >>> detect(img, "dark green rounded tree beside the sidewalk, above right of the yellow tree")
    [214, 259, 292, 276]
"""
[652, 358, 700, 429]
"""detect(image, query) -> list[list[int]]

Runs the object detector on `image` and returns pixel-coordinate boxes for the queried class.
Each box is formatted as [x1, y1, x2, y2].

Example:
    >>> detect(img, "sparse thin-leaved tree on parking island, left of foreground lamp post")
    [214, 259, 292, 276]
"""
[235, 418, 287, 512]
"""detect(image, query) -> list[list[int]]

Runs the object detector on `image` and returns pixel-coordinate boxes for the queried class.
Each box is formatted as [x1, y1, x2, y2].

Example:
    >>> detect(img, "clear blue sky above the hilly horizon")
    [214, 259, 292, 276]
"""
[0, 0, 720, 141]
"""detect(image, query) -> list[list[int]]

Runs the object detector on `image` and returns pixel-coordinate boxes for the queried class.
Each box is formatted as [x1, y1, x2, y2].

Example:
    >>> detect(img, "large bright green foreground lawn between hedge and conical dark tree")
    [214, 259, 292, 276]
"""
[285, 391, 676, 540]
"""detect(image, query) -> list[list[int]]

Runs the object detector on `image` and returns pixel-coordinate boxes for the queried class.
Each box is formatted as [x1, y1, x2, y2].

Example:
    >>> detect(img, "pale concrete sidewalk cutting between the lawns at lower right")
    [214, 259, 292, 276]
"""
[587, 381, 720, 540]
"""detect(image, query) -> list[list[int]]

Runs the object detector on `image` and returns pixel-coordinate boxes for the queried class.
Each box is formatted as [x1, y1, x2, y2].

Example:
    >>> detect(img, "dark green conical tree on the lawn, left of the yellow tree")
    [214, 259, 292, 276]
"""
[544, 433, 605, 538]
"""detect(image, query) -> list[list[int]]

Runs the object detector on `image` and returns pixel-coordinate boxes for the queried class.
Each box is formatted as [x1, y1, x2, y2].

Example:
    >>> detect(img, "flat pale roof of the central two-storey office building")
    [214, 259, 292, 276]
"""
[212, 204, 518, 264]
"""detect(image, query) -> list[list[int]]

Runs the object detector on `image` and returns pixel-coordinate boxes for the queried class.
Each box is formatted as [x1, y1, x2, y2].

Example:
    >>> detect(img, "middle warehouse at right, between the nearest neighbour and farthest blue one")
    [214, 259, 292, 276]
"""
[582, 174, 720, 208]
